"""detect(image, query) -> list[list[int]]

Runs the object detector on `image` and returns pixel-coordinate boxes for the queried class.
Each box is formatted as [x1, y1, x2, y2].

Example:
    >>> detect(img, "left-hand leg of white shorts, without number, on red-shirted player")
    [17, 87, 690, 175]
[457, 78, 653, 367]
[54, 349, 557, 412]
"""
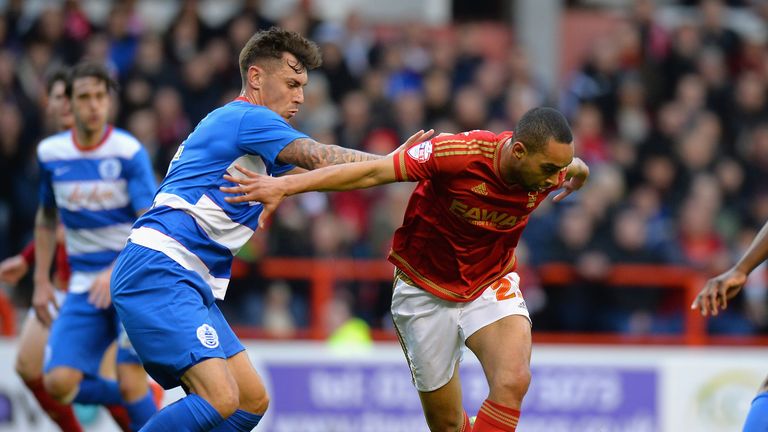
[392, 278, 463, 392]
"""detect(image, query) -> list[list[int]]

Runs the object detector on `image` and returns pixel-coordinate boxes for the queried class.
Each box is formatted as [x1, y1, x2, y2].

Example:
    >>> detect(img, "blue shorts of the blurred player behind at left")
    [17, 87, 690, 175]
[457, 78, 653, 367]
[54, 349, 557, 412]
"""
[44, 292, 140, 376]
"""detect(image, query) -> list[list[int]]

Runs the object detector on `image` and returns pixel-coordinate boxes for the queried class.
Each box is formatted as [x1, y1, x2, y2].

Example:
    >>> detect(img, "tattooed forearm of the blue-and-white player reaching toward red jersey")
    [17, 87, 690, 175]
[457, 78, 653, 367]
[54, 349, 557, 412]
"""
[277, 138, 383, 170]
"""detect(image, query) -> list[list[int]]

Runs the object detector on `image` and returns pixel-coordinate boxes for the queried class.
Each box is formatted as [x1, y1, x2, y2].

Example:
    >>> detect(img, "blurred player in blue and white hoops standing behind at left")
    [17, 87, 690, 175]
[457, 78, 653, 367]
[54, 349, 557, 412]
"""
[33, 63, 157, 430]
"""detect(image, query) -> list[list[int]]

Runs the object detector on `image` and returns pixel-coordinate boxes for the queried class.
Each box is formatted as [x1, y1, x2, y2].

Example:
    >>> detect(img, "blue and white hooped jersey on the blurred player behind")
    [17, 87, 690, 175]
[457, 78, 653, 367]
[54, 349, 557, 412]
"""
[37, 126, 156, 273]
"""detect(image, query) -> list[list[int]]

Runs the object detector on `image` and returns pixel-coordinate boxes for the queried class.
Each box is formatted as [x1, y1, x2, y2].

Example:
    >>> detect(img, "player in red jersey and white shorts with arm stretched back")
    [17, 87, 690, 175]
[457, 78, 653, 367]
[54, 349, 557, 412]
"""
[222, 108, 589, 432]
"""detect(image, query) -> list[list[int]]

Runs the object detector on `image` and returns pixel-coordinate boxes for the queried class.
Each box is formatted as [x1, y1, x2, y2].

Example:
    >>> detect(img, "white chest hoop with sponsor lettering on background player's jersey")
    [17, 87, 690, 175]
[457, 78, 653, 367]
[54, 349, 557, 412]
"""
[53, 179, 131, 212]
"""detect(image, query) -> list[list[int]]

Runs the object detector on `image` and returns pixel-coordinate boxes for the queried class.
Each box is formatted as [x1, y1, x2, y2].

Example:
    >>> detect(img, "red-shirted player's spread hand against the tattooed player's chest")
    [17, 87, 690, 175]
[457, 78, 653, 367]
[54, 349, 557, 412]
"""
[219, 164, 286, 228]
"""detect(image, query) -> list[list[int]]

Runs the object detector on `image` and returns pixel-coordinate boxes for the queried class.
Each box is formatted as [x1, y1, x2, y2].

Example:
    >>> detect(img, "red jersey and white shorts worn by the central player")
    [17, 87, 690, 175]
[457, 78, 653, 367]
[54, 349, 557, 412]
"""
[389, 130, 565, 391]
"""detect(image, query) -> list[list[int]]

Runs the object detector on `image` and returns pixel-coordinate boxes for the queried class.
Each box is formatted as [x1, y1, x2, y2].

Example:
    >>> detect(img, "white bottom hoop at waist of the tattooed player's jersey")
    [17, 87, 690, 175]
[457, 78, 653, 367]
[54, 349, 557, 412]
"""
[129, 227, 229, 300]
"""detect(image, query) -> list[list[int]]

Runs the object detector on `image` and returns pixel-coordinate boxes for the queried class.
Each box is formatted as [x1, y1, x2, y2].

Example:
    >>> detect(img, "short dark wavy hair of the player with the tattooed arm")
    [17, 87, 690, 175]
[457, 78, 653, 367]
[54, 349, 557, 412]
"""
[240, 27, 323, 83]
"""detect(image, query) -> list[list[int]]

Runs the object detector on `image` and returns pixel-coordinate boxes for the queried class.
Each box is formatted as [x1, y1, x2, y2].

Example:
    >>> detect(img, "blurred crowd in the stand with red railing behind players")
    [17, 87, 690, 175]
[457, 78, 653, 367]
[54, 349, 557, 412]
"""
[0, 0, 768, 431]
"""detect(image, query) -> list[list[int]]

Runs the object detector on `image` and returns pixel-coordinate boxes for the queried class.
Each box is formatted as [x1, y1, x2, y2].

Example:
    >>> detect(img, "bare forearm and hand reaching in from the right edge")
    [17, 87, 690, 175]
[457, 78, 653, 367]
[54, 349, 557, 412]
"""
[691, 223, 768, 316]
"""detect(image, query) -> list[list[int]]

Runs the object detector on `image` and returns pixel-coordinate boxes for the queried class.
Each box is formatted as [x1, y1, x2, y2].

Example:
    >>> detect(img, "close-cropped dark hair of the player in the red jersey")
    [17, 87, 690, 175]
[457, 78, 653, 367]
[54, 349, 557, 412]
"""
[513, 107, 573, 153]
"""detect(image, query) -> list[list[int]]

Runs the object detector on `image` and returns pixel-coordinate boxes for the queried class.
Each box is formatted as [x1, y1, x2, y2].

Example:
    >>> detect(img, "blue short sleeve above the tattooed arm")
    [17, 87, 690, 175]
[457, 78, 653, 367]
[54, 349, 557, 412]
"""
[238, 108, 309, 175]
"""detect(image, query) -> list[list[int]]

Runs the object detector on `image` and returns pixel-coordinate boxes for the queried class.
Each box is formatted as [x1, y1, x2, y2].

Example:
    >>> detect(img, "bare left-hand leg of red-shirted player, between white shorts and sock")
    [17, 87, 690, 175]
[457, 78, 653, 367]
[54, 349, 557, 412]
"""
[419, 362, 464, 430]
